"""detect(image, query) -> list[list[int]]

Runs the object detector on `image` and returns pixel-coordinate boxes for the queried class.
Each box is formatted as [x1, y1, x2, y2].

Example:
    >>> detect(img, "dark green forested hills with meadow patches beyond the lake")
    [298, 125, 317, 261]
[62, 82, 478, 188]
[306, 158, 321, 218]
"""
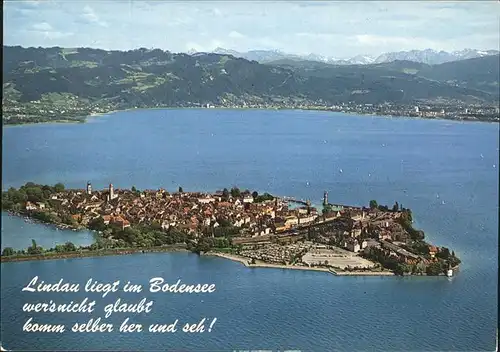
[3, 46, 500, 124]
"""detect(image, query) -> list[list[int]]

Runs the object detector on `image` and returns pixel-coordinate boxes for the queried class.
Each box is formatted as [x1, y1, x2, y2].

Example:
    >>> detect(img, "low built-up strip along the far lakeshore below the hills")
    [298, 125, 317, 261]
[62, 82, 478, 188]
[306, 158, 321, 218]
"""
[2, 95, 500, 123]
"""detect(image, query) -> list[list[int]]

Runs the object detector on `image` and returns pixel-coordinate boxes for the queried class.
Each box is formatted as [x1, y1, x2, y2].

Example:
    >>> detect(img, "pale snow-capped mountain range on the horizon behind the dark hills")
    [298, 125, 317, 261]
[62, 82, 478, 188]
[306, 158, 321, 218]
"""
[204, 48, 499, 65]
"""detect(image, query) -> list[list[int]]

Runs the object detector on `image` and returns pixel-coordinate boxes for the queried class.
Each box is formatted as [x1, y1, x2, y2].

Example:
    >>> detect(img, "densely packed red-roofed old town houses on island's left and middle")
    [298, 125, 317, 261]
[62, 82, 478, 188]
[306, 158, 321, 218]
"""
[33, 183, 328, 238]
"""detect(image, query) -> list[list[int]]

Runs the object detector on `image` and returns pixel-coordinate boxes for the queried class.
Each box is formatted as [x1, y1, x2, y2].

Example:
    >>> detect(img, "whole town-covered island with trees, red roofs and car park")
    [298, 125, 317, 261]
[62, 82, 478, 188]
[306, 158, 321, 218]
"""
[1, 182, 460, 276]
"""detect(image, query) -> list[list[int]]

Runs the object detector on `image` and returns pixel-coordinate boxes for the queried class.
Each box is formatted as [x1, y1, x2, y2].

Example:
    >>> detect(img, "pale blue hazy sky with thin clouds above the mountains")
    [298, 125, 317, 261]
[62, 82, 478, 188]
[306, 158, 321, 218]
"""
[4, 0, 500, 58]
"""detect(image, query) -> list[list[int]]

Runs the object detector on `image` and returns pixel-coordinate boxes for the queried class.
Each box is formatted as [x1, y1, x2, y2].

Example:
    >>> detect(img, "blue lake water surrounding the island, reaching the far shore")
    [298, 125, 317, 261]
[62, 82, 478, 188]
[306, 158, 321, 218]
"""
[1, 109, 499, 351]
